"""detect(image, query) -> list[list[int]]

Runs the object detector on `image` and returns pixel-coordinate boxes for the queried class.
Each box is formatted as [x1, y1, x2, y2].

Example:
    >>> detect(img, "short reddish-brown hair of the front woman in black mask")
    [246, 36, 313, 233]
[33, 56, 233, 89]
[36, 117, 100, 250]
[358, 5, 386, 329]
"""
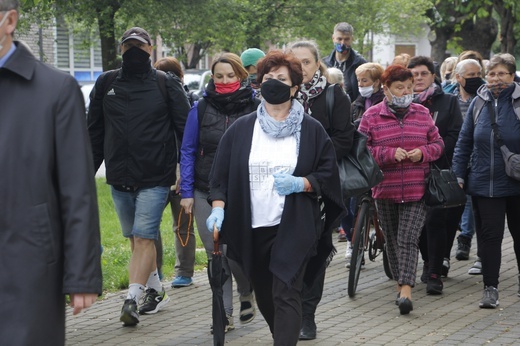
[256, 49, 303, 87]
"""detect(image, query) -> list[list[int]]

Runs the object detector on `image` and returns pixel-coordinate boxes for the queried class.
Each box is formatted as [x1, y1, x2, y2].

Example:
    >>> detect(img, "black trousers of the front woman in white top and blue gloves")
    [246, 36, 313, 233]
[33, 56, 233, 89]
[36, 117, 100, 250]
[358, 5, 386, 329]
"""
[251, 226, 307, 346]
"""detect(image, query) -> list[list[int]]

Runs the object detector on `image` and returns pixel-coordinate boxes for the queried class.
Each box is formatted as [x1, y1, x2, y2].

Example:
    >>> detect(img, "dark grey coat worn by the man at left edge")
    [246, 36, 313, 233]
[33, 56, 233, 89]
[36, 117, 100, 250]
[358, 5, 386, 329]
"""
[0, 42, 102, 346]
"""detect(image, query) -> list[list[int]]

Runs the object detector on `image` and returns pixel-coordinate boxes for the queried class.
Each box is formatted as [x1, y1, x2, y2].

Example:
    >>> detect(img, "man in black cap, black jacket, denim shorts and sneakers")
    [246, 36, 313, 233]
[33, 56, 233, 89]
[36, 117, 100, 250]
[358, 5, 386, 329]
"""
[88, 24, 190, 326]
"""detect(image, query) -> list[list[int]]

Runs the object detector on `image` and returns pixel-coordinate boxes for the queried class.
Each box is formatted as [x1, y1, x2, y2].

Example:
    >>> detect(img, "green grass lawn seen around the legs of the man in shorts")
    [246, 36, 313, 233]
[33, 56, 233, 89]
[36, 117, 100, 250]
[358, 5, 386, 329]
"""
[96, 178, 207, 292]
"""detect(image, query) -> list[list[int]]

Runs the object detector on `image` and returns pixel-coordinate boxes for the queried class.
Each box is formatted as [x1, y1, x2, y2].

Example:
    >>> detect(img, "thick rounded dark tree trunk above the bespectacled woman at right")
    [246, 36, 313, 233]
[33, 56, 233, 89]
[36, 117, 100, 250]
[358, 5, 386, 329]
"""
[459, 6, 498, 59]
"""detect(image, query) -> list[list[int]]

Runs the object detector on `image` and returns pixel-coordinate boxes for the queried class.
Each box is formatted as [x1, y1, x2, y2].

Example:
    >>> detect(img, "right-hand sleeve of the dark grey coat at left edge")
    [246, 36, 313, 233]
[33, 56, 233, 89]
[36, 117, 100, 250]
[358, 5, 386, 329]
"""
[54, 77, 102, 294]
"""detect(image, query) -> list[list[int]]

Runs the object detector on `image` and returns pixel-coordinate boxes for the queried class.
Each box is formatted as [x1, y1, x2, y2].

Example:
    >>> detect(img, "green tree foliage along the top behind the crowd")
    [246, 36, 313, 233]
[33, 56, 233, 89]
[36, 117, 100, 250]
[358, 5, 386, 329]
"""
[18, 0, 431, 69]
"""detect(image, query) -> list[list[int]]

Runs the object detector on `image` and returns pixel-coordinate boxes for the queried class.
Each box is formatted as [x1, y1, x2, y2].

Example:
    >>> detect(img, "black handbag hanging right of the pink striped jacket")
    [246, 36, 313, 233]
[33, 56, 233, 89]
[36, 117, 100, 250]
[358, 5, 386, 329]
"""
[424, 164, 466, 208]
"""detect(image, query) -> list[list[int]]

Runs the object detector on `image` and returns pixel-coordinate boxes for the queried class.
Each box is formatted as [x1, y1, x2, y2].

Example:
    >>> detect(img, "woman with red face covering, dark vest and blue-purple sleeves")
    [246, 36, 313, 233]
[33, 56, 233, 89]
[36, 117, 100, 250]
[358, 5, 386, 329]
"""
[180, 53, 260, 332]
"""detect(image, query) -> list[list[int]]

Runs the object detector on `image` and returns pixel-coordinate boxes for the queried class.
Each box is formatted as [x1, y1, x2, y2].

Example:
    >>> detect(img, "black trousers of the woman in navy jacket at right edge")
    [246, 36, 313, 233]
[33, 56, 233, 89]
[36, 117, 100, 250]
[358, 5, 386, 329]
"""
[472, 196, 520, 288]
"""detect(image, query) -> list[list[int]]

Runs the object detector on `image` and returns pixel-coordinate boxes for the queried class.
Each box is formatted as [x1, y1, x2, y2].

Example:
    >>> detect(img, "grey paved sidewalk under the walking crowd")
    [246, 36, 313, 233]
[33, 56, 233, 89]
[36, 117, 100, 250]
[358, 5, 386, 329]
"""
[66, 230, 520, 346]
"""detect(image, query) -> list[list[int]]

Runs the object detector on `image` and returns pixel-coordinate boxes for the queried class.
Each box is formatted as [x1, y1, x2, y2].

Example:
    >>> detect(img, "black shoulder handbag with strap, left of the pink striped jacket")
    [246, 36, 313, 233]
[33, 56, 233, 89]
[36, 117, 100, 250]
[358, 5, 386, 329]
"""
[326, 85, 383, 198]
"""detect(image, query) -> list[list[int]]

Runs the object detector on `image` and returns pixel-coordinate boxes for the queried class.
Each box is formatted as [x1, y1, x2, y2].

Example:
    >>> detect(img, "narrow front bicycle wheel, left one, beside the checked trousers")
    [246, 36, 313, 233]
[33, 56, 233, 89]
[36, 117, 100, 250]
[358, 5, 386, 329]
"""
[347, 201, 370, 297]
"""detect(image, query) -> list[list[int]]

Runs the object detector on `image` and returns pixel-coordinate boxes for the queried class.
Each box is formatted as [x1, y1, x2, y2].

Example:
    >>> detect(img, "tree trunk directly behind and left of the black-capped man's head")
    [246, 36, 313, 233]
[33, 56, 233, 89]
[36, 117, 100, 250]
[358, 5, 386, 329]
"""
[96, 1, 121, 71]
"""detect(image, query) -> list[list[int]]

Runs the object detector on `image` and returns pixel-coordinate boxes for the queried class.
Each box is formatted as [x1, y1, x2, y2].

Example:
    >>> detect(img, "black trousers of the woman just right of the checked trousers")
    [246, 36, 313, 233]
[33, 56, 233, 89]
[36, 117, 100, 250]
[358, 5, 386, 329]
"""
[419, 206, 464, 276]
